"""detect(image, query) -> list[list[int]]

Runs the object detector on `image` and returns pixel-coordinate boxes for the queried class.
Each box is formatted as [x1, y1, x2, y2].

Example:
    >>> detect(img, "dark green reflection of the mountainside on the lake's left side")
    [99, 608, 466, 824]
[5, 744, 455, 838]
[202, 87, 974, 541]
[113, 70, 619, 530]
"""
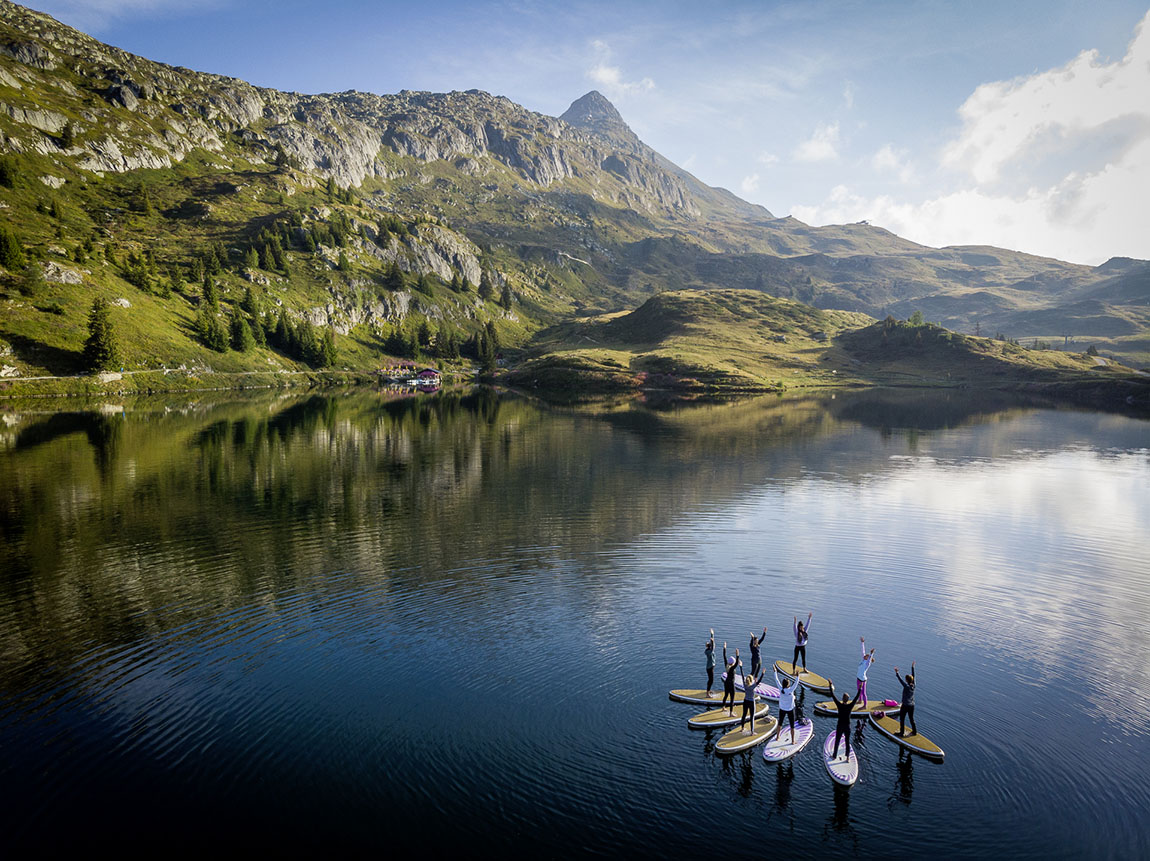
[0, 390, 1145, 703]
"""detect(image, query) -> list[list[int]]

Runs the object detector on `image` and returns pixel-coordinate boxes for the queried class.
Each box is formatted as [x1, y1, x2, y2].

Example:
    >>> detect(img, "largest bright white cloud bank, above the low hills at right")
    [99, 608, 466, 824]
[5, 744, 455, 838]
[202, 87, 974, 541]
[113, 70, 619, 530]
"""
[792, 13, 1150, 263]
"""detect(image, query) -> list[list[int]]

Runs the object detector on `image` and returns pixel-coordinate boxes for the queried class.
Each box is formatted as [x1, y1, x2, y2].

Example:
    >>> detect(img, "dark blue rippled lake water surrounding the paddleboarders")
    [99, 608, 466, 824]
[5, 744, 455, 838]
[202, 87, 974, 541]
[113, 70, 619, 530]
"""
[0, 391, 1150, 858]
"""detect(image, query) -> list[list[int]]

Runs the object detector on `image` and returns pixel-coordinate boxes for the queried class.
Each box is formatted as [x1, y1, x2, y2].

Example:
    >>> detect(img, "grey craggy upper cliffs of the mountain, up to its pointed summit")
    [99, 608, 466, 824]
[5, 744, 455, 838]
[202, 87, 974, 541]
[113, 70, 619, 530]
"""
[0, 0, 769, 220]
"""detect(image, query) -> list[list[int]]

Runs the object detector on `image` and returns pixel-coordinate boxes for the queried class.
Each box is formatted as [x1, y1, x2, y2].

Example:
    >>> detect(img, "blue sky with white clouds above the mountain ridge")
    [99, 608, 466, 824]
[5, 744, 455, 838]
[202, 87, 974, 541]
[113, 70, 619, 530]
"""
[22, 0, 1150, 264]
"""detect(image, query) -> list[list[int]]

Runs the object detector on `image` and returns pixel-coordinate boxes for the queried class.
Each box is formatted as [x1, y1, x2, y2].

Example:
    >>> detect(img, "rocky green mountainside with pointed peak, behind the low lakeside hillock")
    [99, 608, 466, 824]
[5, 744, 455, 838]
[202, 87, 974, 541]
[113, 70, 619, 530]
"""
[0, 1, 1150, 383]
